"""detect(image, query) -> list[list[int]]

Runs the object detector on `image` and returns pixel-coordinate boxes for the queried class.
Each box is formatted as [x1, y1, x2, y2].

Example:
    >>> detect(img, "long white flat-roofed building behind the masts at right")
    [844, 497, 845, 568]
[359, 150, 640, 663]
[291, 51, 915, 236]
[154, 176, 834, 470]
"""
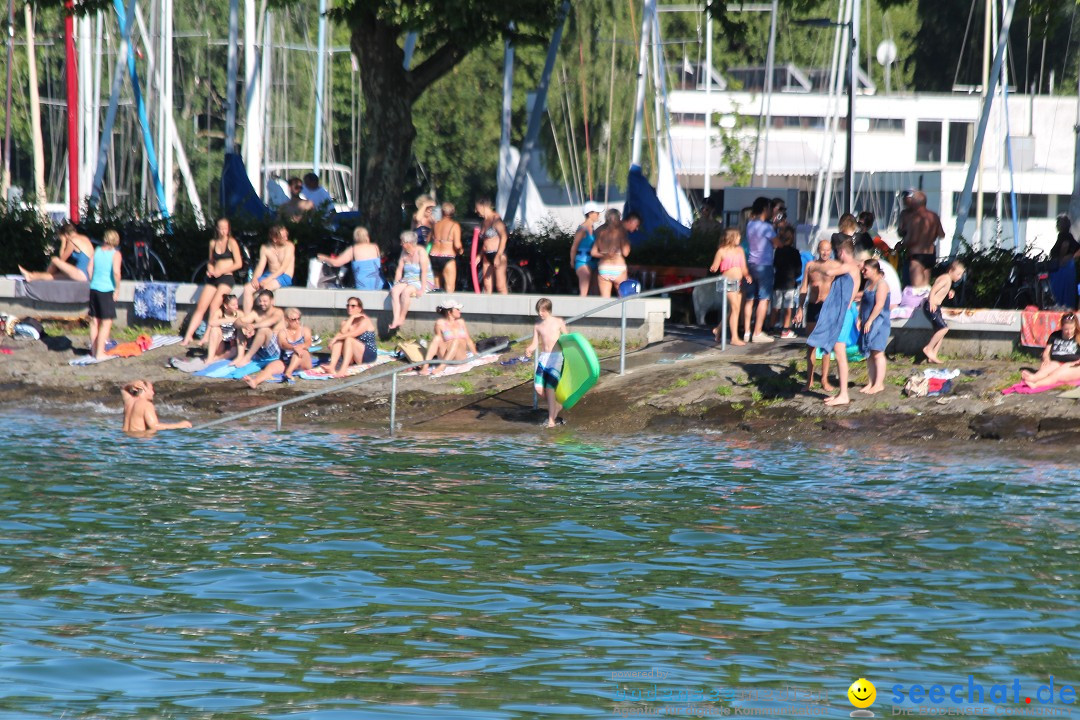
[669, 66, 1077, 252]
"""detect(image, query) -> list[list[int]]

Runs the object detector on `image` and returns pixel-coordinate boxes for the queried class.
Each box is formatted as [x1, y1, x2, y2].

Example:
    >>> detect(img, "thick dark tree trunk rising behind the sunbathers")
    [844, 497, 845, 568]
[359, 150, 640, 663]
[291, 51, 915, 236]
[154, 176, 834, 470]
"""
[349, 11, 416, 249]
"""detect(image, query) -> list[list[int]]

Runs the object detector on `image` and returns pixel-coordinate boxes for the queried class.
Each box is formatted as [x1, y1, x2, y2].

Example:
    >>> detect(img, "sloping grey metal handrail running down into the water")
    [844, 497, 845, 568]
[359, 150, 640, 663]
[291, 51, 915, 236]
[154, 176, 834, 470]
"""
[192, 276, 728, 437]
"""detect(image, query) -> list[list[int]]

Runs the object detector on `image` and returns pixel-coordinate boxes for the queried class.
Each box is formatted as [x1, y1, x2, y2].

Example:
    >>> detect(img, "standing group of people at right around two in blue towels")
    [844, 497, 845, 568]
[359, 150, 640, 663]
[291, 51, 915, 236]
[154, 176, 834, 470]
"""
[694, 191, 980, 405]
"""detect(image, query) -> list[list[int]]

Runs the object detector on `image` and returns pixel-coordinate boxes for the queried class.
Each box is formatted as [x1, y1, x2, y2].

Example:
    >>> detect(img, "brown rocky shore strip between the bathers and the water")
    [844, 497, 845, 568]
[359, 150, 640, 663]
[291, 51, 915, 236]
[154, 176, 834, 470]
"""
[0, 336, 1080, 446]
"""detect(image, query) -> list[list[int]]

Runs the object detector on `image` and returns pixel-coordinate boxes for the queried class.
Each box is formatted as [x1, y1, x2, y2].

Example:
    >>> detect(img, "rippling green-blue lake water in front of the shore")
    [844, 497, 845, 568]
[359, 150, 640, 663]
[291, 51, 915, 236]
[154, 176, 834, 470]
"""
[0, 409, 1080, 720]
